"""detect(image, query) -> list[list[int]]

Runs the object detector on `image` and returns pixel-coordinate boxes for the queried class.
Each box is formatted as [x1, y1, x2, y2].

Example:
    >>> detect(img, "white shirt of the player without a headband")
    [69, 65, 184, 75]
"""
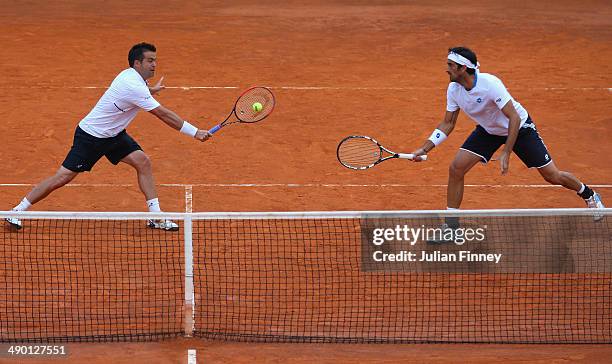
[79, 67, 160, 138]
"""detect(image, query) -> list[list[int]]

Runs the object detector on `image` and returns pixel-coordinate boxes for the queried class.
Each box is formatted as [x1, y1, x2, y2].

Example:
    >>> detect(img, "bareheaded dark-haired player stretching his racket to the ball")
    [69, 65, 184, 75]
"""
[6, 43, 211, 231]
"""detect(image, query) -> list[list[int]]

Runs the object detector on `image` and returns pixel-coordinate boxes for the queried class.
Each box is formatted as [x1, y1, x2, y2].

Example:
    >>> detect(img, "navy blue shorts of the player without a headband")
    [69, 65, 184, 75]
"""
[62, 126, 142, 172]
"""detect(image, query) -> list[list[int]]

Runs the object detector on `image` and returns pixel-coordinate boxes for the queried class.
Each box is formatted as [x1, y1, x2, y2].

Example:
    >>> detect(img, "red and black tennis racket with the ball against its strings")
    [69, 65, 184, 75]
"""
[208, 86, 275, 134]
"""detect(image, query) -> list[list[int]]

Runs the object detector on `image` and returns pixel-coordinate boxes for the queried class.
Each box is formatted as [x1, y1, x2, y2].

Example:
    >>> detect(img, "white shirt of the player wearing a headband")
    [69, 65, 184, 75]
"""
[446, 73, 528, 136]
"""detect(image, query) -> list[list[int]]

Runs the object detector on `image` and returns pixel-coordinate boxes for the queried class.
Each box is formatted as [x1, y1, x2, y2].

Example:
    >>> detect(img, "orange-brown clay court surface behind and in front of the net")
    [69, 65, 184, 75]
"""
[0, 0, 612, 363]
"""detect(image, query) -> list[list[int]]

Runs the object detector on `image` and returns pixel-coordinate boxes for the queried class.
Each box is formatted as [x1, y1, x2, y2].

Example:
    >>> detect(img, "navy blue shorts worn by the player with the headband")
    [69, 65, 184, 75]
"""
[461, 117, 552, 168]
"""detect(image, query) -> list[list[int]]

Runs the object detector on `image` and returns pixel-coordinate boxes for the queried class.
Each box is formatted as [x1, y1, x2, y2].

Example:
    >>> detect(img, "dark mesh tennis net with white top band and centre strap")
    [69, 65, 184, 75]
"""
[0, 209, 612, 343]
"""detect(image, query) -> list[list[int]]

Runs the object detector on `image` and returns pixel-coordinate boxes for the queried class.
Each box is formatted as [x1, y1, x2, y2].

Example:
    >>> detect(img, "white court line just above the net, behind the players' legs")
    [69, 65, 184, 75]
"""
[0, 183, 612, 188]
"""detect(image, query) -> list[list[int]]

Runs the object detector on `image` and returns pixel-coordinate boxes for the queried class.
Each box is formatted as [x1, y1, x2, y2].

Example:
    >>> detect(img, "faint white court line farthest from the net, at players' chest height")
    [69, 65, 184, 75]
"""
[0, 85, 612, 92]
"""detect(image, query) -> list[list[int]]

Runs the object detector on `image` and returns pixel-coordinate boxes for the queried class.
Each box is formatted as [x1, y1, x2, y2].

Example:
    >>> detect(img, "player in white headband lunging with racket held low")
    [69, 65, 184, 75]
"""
[413, 47, 604, 222]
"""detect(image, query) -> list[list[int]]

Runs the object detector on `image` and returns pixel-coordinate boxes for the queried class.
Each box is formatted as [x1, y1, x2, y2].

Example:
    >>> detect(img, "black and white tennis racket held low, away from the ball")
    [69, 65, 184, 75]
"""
[336, 135, 427, 169]
